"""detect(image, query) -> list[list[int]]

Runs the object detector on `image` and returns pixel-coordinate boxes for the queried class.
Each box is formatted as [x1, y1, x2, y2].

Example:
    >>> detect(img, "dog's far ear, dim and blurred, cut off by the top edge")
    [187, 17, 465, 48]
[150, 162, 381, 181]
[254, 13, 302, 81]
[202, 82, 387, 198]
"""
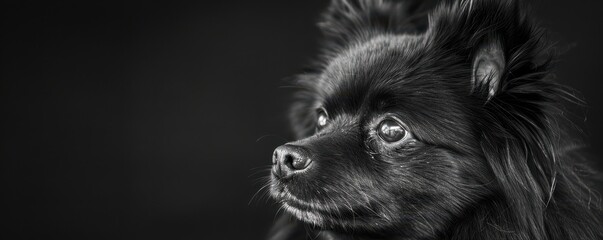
[318, 0, 437, 51]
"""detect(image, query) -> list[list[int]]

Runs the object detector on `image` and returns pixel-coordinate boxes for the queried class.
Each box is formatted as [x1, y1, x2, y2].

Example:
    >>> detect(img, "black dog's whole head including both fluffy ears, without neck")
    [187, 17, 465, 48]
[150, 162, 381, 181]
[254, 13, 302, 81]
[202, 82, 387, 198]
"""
[271, 0, 560, 236]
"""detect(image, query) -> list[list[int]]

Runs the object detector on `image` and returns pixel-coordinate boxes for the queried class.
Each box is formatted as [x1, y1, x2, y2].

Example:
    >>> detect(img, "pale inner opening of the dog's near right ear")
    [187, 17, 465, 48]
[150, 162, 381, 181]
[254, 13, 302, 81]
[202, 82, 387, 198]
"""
[471, 40, 506, 100]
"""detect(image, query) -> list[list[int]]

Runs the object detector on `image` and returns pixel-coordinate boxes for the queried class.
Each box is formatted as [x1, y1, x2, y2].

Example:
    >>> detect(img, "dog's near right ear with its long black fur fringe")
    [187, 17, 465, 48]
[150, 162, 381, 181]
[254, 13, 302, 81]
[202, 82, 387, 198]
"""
[426, 0, 554, 101]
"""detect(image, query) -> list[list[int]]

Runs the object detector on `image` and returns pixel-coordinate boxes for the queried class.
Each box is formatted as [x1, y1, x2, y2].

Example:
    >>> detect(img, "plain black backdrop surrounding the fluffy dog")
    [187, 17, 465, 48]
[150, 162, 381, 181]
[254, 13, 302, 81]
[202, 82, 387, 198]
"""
[0, 0, 603, 239]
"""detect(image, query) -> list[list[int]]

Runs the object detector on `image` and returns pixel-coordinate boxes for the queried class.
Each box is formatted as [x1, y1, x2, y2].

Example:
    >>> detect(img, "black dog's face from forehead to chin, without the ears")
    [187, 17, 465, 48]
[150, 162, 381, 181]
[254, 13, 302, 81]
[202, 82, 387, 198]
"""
[272, 36, 484, 234]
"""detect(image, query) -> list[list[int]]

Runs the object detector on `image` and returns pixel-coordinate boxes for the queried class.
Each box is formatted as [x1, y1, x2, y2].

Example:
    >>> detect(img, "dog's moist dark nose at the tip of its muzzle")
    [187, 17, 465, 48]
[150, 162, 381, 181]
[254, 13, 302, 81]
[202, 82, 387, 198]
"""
[272, 145, 312, 178]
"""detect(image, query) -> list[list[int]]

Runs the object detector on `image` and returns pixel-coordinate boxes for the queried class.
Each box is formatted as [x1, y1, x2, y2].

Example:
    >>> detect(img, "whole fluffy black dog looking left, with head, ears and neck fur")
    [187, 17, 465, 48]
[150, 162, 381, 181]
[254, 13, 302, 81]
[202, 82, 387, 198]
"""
[270, 0, 603, 240]
